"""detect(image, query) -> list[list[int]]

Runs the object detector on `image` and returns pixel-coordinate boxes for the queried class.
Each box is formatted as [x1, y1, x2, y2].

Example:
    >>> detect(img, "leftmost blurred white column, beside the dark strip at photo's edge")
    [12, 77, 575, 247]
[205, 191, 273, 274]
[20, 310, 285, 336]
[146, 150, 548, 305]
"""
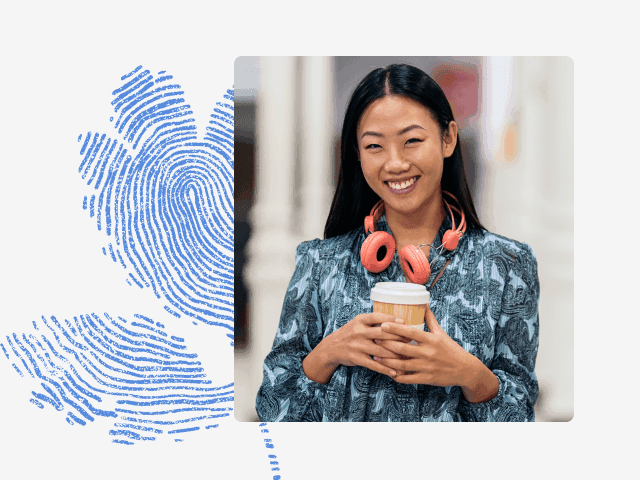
[241, 57, 297, 418]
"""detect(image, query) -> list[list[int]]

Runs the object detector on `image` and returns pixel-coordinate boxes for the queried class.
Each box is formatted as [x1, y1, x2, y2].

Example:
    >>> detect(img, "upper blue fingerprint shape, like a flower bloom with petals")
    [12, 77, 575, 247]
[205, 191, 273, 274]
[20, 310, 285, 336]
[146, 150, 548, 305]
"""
[78, 66, 233, 345]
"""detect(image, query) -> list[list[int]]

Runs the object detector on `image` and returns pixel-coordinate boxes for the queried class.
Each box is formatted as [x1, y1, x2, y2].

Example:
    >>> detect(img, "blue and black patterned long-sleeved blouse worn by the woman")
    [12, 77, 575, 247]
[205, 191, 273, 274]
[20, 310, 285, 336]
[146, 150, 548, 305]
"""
[256, 212, 540, 422]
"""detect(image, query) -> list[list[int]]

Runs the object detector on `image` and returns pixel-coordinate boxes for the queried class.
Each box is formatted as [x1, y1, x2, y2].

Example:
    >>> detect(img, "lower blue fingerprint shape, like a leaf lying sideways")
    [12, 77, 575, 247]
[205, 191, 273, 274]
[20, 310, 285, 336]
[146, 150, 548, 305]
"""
[0, 313, 233, 445]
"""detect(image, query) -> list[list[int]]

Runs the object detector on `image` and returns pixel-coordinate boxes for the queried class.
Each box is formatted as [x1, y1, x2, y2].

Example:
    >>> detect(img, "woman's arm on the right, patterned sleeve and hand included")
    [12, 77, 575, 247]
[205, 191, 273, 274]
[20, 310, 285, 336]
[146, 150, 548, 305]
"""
[374, 247, 539, 421]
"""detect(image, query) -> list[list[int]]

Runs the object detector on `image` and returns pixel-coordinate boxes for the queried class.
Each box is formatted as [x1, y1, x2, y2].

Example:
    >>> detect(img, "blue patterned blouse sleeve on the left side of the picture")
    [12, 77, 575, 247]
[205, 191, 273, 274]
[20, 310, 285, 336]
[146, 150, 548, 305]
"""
[256, 240, 326, 422]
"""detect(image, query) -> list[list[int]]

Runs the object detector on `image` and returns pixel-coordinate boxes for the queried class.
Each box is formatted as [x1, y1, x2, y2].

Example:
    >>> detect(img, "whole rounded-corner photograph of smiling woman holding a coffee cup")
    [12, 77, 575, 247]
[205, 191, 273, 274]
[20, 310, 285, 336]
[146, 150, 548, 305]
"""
[234, 56, 574, 422]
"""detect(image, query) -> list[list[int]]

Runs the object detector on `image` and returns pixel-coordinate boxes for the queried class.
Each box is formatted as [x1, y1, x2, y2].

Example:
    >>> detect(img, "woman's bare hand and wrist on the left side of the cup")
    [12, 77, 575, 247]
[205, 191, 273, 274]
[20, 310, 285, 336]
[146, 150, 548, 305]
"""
[302, 313, 405, 383]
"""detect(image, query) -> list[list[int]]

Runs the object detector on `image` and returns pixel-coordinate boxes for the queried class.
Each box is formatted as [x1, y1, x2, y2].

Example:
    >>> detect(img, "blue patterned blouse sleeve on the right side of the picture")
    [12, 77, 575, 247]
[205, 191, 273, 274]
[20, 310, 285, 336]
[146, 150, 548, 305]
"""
[460, 245, 540, 422]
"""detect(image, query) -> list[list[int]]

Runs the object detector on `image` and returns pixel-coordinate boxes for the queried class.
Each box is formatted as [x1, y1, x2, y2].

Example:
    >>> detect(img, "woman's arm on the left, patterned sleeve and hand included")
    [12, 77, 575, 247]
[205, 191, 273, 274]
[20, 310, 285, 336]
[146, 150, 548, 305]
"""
[256, 242, 401, 422]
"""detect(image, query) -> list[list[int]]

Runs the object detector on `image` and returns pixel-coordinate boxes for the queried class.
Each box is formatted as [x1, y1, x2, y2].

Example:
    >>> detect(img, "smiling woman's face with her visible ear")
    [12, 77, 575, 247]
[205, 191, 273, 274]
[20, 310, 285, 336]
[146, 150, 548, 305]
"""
[357, 95, 457, 218]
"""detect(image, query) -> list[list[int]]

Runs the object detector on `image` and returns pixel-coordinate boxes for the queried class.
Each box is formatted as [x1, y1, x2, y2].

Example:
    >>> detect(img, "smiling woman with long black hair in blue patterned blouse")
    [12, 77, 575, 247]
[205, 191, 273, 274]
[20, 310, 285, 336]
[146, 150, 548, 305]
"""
[256, 65, 539, 421]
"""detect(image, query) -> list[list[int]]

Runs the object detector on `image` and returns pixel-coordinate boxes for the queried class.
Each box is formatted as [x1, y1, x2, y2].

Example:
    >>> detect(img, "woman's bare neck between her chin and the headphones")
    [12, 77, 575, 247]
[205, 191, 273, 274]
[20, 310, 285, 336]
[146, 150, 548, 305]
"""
[385, 190, 446, 245]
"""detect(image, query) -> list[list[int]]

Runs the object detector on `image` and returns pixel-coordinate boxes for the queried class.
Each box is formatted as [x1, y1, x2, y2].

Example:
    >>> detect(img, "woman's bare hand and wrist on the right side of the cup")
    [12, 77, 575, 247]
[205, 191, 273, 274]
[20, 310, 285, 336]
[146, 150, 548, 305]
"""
[374, 306, 499, 403]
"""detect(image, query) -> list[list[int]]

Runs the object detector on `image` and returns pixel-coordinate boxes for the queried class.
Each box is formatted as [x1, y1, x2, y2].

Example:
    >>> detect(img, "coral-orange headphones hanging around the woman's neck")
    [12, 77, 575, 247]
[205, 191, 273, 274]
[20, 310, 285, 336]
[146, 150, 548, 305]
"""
[360, 190, 467, 285]
